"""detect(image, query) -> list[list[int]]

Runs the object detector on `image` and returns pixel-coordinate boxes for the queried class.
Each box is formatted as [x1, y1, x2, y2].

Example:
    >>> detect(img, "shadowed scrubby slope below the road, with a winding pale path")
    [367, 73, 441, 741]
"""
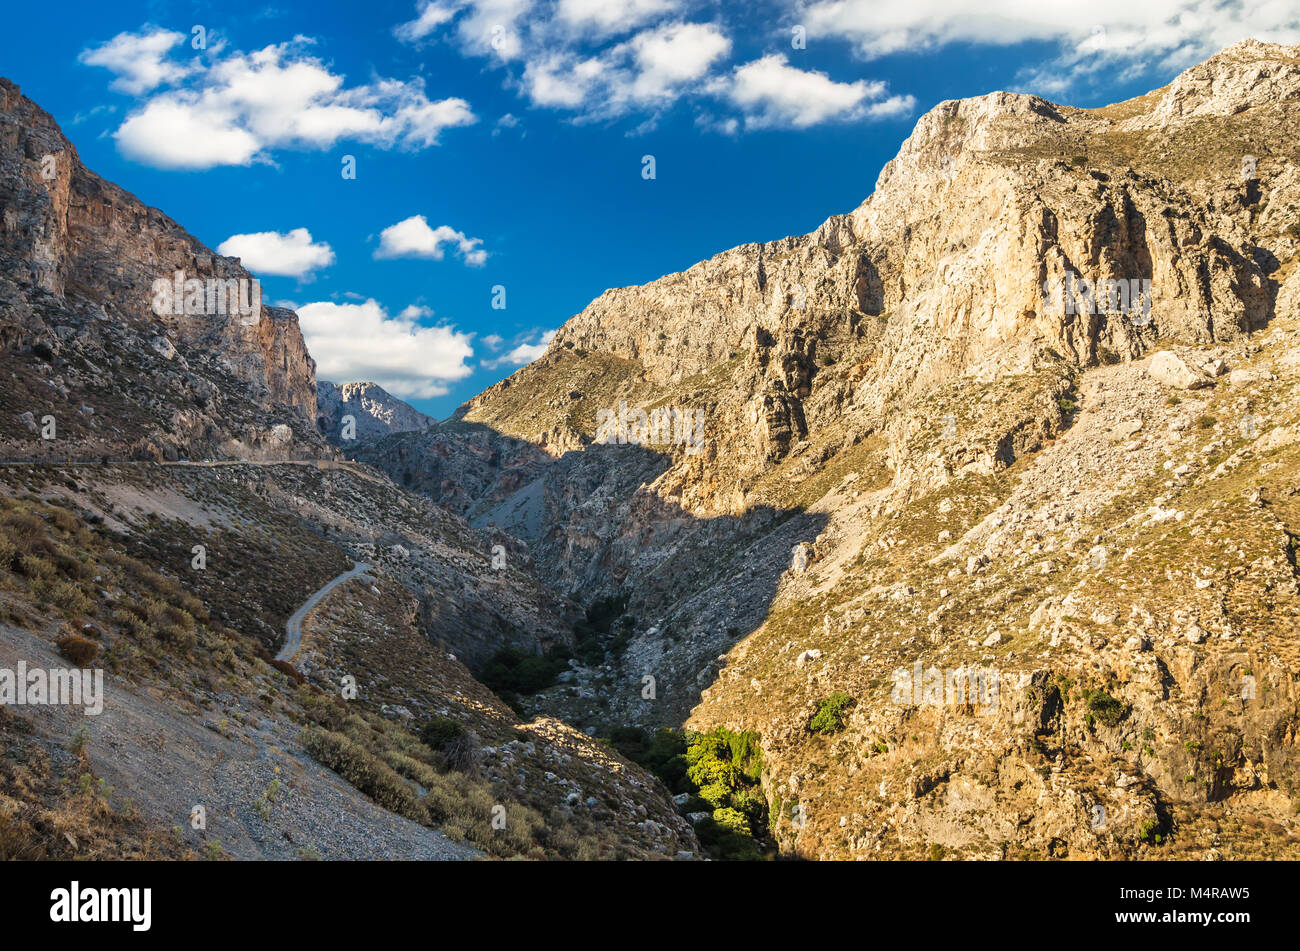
[0, 464, 699, 859]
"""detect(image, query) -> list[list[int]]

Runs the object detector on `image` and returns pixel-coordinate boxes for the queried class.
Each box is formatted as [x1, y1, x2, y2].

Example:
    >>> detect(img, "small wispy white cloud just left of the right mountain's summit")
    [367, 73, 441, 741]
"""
[712, 53, 917, 129]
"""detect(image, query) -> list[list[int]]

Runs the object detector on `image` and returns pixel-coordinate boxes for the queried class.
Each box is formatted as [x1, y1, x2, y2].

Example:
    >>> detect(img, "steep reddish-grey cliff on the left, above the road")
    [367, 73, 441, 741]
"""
[0, 81, 321, 456]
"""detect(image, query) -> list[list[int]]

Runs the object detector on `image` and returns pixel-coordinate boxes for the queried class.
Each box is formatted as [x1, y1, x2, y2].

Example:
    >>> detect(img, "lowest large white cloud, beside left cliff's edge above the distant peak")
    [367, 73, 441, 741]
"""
[298, 300, 473, 399]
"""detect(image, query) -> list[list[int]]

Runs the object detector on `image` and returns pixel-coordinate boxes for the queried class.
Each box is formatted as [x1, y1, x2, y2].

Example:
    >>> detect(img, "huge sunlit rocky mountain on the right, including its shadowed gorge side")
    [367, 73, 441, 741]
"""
[350, 42, 1300, 857]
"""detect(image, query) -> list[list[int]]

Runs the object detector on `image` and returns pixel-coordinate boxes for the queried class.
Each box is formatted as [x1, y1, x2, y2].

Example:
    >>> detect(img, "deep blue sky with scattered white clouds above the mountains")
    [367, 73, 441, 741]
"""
[0, 0, 1300, 417]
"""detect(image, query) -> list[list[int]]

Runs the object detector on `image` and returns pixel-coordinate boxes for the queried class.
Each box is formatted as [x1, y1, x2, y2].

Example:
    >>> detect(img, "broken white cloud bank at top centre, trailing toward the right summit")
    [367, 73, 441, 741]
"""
[397, 0, 933, 129]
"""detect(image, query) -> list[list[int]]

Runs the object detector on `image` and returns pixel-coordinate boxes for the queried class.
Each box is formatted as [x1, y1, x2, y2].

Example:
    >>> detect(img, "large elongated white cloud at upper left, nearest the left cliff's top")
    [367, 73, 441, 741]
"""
[91, 34, 476, 169]
